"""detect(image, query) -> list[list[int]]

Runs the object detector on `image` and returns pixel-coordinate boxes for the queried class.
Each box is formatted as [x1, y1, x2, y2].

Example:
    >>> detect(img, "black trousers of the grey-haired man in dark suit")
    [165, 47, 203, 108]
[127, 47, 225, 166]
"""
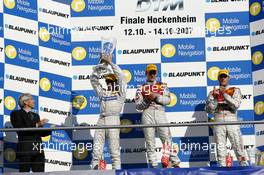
[19, 154, 45, 172]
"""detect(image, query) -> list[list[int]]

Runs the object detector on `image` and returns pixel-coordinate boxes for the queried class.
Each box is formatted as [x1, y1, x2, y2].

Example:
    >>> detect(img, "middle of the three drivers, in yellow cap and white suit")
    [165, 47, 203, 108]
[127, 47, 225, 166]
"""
[135, 64, 180, 168]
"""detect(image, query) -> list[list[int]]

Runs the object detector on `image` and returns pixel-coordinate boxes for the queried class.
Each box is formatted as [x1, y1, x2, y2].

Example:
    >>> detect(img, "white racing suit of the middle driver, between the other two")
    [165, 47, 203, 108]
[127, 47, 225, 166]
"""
[135, 82, 180, 167]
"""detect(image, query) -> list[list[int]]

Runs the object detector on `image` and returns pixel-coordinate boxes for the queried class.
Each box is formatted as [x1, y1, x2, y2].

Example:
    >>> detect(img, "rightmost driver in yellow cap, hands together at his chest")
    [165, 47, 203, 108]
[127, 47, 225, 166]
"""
[205, 69, 247, 167]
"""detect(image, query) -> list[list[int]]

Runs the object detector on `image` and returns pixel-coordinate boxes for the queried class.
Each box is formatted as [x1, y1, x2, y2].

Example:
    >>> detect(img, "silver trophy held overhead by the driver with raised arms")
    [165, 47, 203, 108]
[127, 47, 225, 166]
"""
[93, 38, 116, 76]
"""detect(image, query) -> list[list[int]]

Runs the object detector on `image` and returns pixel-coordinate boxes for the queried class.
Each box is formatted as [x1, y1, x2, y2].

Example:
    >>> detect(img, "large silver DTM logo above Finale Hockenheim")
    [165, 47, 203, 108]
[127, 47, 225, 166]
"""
[136, 0, 183, 12]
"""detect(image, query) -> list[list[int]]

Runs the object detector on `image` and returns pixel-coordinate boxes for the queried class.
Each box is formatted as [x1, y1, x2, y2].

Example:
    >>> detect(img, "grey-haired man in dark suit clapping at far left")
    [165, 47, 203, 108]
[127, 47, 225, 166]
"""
[10, 93, 51, 172]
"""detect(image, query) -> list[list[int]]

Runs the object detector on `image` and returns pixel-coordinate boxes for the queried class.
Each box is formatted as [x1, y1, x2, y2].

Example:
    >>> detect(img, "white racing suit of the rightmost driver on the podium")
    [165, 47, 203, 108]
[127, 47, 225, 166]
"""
[205, 87, 247, 167]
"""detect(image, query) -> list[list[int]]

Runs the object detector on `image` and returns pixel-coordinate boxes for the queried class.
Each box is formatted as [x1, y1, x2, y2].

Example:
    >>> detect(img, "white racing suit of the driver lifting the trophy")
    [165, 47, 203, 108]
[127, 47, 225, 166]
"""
[91, 63, 126, 169]
